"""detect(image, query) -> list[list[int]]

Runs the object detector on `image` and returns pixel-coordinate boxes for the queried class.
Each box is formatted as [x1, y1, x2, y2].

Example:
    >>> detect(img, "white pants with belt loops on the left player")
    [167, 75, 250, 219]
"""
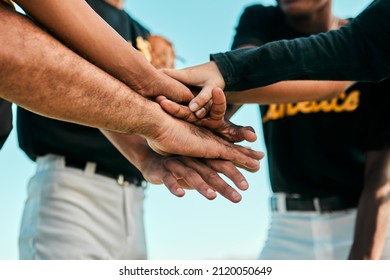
[19, 156, 146, 259]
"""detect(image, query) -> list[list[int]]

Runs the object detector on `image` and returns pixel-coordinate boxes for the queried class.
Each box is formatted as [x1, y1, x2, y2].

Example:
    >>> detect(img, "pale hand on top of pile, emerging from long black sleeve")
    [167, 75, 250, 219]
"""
[163, 61, 225, 117]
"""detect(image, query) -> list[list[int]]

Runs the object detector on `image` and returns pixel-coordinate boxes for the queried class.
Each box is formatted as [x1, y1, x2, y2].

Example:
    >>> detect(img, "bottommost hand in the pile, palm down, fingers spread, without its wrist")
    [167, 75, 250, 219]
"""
[140, 151, 248, 203]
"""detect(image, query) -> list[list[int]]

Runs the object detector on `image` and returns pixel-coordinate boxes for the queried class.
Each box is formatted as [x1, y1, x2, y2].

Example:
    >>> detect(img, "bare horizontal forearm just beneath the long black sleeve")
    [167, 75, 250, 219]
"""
[226, 81, 353, 104]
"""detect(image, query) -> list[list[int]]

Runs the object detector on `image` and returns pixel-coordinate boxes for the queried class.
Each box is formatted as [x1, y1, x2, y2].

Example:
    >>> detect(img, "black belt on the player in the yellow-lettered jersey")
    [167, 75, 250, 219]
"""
[271, 194, 358, 213]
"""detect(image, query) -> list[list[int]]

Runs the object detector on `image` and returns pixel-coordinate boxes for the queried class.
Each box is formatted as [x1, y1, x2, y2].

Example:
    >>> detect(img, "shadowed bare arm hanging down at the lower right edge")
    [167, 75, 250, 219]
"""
[349, 151, 390, 259]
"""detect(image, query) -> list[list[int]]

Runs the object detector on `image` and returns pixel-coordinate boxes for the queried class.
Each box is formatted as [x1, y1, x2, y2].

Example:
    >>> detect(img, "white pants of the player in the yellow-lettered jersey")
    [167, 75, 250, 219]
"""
[259, 209, 390, 260]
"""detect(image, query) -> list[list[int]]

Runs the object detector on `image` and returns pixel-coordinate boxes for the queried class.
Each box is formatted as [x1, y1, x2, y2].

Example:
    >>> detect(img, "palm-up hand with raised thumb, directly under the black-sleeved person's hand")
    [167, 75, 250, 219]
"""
[156, 88, 257, 142]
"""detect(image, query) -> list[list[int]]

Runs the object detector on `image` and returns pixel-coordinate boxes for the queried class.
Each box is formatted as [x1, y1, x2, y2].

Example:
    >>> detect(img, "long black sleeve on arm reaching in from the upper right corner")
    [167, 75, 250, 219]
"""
[211, 0, 390, 91]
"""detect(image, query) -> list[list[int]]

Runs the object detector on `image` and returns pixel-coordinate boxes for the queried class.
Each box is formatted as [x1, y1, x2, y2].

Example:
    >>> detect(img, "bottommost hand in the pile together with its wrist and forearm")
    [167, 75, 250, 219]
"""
[102, 131, 248, 203]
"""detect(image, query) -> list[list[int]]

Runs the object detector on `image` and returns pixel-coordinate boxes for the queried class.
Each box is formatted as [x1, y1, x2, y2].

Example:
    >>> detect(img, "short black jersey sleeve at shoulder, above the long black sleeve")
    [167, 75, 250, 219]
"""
[232, 5, 267, 50]
